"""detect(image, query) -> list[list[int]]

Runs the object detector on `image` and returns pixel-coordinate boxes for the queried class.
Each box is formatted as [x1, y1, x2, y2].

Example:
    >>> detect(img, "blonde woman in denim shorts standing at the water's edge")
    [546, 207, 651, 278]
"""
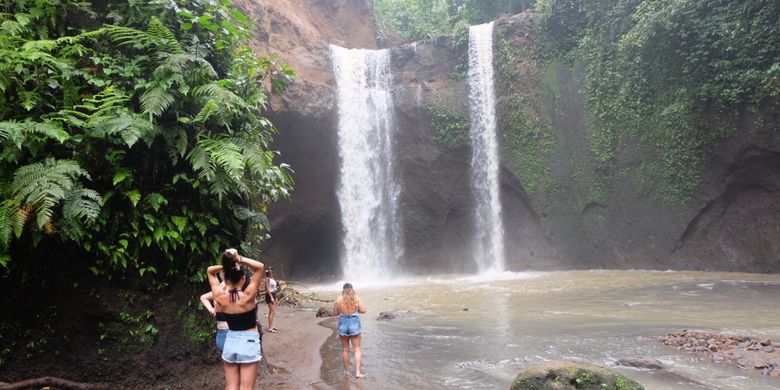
[333, 283, 366, 378]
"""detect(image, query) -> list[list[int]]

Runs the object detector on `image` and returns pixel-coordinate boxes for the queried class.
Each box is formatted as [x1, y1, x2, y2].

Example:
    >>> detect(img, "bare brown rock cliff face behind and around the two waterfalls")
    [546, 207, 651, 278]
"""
[247, 0, 780, 277]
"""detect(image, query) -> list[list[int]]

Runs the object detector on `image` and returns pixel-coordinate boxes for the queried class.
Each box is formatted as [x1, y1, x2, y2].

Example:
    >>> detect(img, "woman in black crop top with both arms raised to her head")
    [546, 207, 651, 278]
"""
[208, 248, 264, 390]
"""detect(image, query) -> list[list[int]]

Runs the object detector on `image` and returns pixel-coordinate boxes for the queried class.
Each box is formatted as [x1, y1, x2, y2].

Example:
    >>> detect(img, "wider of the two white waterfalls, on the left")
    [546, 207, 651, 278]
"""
[330, 45, 403, 282]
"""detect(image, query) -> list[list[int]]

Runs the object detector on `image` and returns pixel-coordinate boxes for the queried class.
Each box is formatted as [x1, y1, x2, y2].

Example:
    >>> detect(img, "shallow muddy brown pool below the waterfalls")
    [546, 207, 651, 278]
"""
[315, 271, 780, 390]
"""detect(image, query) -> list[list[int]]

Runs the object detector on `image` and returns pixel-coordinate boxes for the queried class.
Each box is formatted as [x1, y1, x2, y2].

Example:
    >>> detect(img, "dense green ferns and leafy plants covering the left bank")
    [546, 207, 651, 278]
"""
[0, 0, 293, 278]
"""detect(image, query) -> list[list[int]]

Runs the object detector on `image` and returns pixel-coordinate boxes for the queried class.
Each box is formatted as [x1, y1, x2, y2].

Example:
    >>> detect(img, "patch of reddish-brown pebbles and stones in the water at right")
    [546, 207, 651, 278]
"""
[661, 330, 780, 378]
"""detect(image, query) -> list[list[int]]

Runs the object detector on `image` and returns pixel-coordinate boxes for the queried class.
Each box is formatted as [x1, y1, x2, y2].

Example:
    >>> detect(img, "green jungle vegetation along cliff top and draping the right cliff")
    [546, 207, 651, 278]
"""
[375, 0, 780, 205]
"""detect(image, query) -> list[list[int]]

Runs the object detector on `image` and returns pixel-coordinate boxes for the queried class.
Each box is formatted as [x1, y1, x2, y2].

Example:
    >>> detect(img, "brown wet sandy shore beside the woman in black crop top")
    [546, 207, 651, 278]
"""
[256, 306, 333, 389]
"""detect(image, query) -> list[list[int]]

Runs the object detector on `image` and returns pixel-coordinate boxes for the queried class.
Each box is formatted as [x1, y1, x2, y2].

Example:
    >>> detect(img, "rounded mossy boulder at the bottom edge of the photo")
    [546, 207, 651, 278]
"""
[510, 361, 644, 390]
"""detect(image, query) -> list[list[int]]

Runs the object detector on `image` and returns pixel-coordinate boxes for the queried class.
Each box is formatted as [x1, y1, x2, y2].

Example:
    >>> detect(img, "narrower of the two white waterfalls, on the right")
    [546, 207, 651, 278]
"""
[469, 22, 504, 273]
